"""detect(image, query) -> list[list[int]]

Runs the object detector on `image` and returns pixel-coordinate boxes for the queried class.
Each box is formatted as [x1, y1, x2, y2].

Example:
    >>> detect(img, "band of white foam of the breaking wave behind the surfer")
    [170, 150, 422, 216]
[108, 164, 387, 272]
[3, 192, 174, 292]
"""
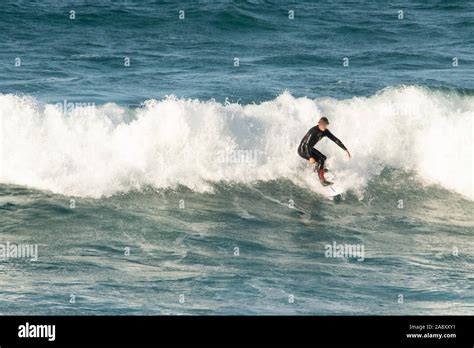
[0, 86, 474, 199]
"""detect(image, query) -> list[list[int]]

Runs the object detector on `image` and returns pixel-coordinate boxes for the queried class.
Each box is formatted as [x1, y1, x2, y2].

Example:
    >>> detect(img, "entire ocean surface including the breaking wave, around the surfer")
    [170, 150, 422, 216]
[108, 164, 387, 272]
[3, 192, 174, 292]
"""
[0, 0, 474, 315]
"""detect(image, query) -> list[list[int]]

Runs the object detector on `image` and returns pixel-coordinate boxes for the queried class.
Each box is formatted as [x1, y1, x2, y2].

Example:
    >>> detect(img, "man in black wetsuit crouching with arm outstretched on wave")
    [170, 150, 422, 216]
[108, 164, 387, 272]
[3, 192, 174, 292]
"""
[298, 117, 351, 186]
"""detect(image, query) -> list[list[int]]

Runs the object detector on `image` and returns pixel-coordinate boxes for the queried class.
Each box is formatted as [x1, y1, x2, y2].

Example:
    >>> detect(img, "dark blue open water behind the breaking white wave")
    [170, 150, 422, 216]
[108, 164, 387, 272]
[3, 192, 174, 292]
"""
[0, 1, 474, 104]
